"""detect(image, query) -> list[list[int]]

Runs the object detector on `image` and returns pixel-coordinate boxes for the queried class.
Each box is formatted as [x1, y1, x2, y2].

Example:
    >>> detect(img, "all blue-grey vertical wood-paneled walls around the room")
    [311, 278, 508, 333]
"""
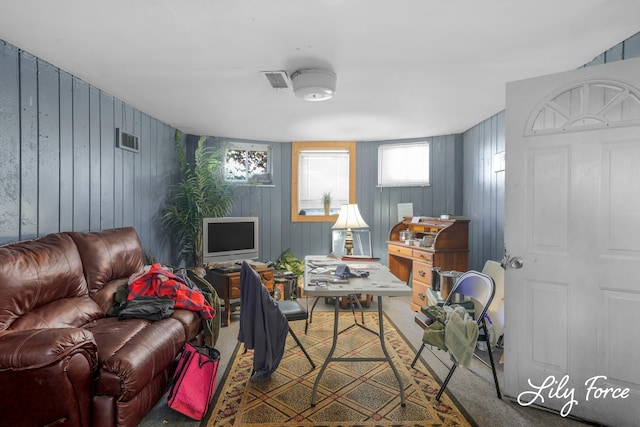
[0, 30, 640, 269]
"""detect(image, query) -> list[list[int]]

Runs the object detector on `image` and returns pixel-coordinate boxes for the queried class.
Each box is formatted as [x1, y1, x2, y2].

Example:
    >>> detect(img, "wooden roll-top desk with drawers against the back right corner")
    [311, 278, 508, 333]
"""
[387, 217, 469, 312]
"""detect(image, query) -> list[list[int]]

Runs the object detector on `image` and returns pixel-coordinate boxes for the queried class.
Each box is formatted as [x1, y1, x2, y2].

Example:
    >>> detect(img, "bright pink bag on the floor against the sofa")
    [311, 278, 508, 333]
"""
[167, 342, 220, 420]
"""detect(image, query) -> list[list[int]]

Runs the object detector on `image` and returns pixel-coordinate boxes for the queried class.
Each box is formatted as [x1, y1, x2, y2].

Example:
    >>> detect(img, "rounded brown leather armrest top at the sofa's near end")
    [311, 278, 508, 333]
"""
[0, 328, 98, 372]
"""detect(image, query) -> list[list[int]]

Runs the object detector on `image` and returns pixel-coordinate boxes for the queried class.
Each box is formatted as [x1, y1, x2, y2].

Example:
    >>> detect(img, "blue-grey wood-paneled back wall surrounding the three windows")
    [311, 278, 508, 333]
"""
[214, 135, 462, 264]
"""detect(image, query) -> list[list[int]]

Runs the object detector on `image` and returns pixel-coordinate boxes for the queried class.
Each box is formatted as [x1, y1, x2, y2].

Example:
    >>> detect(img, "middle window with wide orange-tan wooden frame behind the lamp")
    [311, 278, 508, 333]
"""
[291, 141, 356, 222]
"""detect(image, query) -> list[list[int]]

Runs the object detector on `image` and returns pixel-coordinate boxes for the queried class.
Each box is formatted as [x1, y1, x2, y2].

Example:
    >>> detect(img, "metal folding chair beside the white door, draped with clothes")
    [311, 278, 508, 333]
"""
[411, 270, 502, 401]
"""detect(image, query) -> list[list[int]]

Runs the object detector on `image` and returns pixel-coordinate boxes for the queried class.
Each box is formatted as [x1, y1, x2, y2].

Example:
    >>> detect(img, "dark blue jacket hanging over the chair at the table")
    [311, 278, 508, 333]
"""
[238, 261, 289, 381]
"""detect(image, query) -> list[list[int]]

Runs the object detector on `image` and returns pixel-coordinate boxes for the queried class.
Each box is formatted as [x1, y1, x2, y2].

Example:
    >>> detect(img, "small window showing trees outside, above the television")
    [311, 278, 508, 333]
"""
[224, 142, 272, 185]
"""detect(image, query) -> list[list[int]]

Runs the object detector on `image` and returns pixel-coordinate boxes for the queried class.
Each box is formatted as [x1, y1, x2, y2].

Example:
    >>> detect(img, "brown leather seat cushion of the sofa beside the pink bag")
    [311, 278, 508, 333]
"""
[85, 317, 185, 401]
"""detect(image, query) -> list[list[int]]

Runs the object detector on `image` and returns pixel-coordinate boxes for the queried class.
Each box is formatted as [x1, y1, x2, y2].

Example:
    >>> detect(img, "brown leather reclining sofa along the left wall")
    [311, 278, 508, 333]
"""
[0, 228, 202, 427]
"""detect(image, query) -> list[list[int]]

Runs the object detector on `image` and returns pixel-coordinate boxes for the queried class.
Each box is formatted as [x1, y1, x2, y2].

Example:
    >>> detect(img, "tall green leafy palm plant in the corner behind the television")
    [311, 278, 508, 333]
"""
[162, 130, 236, 267]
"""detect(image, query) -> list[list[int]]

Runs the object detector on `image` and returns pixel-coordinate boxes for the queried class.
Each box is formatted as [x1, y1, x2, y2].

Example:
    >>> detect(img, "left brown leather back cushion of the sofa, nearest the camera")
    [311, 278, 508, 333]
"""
[0, 233, 88, 330]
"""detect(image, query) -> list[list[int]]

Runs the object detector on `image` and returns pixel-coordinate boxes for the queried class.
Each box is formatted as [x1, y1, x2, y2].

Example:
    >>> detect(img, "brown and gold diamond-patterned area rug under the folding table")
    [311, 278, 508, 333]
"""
[203, 312, 475, 427]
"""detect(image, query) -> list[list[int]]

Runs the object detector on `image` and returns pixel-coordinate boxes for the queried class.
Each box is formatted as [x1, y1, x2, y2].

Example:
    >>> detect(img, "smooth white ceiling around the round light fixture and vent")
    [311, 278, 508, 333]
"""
[0, 0, 640, 141]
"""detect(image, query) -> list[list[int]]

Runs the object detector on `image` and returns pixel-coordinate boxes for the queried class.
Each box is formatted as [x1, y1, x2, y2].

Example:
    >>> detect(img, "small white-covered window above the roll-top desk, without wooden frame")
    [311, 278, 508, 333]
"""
[378, 141, 429, 187]
